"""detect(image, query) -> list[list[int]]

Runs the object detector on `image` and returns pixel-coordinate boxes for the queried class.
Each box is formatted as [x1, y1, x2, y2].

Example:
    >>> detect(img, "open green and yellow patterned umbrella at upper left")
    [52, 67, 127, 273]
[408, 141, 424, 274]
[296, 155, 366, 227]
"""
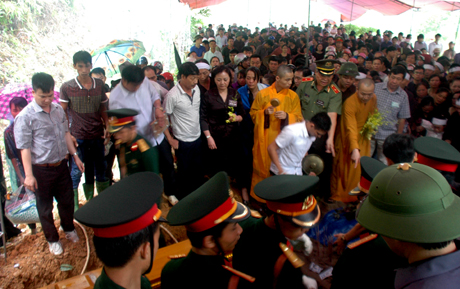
[91, 39, 145, 78]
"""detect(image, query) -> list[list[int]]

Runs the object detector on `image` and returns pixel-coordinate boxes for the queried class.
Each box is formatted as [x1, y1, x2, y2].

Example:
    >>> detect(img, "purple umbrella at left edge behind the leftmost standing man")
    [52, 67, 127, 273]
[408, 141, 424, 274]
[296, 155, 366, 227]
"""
[0, 83, 59, 119]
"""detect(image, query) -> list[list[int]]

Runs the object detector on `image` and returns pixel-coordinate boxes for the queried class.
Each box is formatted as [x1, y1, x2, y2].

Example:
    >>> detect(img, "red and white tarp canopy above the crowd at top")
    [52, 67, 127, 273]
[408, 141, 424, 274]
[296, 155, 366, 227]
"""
[180, 0, 460, 22]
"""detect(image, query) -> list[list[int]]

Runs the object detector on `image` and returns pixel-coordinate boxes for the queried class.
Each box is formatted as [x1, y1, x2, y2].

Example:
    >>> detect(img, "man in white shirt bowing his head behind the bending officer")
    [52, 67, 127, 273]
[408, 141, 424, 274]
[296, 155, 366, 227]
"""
[109, 65, 177, 205]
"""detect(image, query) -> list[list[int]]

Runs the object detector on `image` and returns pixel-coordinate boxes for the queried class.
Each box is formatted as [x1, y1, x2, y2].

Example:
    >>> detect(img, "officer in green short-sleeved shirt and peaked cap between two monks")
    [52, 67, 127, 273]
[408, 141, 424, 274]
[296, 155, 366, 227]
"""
[296, 59, 342, 200]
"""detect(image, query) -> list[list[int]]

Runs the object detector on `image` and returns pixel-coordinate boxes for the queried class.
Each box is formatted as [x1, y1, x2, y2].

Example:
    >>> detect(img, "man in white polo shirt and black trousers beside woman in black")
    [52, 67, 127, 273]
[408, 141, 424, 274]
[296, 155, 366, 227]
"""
[165, 62, 204, 200]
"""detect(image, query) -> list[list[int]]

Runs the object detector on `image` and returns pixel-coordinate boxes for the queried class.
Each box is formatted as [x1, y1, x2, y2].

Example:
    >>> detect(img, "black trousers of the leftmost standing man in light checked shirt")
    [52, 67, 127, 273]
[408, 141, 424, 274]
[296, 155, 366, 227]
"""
[32, 160, 75, 242]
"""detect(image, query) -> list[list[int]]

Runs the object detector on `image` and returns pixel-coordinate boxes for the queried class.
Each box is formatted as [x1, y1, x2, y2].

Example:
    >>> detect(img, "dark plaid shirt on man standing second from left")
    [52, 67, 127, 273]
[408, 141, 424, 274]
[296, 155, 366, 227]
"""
[59, 77, 108, 139]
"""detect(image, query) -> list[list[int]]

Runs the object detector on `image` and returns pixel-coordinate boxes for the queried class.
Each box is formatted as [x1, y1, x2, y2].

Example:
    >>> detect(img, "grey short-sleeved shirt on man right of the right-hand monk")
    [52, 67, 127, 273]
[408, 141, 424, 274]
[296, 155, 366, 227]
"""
[374, 82, 410, 140]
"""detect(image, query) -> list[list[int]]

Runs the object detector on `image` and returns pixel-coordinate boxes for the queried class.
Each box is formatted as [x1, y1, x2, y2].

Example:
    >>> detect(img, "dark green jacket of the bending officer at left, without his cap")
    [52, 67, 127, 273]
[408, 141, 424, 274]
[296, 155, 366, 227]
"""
[119, 134, 160, 176]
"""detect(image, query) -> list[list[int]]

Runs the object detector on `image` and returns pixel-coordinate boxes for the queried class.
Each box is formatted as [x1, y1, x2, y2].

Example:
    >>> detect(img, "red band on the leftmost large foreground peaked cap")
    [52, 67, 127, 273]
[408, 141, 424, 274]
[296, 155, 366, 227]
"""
[93, 204, 161, 238]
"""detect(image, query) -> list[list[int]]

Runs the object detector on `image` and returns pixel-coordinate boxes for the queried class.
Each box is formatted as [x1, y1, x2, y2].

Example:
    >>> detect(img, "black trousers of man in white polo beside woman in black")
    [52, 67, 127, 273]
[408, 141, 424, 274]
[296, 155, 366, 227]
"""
[176, 137, 204, 200]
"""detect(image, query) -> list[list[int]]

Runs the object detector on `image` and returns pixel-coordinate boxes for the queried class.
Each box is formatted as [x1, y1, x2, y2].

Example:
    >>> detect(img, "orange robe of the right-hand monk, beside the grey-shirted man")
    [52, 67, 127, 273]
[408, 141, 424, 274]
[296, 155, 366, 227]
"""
[331, 92, 377, 203]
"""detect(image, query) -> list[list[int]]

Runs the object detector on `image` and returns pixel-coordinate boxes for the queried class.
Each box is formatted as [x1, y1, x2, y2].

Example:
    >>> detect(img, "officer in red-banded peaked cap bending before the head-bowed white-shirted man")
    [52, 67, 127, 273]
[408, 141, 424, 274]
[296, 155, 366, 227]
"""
[107, 108, 159, 178]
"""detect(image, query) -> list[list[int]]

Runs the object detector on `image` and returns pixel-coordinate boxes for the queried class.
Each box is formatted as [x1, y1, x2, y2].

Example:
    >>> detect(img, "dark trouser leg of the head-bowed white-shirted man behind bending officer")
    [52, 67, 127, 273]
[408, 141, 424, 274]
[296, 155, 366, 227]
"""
[157, 137, 175, 196]
